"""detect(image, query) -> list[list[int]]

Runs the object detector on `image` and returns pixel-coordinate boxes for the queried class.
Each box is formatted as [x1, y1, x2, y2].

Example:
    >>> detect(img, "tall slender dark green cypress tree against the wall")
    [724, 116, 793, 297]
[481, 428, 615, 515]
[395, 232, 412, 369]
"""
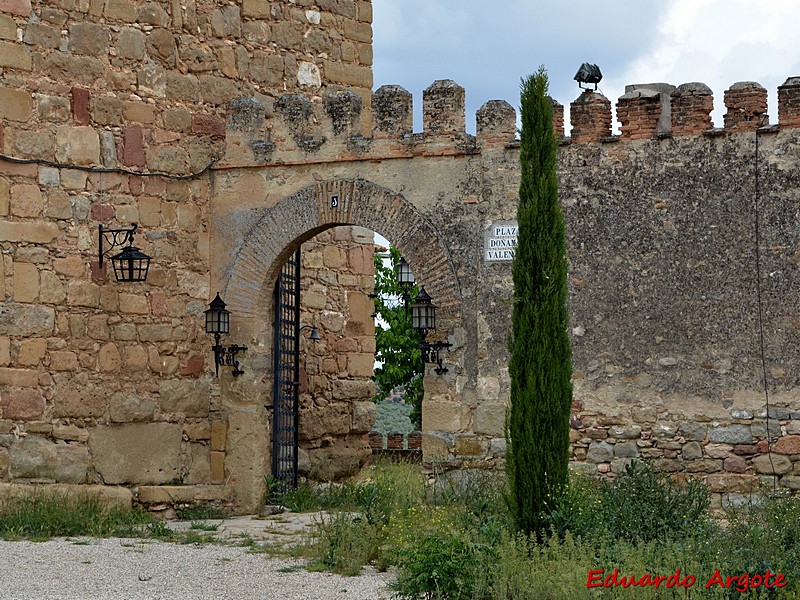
[506, 67, 572, 536]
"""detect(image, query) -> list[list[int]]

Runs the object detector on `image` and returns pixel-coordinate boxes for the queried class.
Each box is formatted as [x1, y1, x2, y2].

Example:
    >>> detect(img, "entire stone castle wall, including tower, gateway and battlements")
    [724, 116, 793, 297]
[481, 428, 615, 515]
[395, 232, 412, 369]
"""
[0, 0, 800, 511]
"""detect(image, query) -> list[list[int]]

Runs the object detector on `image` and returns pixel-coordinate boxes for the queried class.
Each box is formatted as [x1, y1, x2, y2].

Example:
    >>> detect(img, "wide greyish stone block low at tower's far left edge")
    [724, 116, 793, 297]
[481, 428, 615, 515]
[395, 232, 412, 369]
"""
[9, 435, 90, 484]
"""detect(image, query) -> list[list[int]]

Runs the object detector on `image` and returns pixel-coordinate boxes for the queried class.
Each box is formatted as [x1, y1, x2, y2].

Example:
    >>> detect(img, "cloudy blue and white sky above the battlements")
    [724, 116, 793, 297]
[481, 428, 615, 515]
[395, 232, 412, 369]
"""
[373, 0, 800, 134]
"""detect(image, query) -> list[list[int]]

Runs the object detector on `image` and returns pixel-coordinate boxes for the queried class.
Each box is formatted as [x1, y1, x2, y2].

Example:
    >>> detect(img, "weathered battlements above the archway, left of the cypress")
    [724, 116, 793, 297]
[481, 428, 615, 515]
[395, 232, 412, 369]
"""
[221, 79, 520, 166]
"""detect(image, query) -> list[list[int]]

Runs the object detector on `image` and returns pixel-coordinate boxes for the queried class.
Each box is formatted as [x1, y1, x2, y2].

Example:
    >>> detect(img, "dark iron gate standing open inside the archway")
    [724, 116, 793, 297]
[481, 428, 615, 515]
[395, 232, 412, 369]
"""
[272, 248, 300, 493]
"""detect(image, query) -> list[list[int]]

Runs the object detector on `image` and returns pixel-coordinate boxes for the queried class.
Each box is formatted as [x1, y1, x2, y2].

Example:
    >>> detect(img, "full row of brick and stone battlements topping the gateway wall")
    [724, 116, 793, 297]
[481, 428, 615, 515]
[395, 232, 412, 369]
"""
[223, 77, 800, 166]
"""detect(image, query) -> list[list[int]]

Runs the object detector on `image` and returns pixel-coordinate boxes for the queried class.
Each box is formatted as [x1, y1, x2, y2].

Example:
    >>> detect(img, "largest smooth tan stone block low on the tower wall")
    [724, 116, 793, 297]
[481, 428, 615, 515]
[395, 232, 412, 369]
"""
[89, 423, 182, 485]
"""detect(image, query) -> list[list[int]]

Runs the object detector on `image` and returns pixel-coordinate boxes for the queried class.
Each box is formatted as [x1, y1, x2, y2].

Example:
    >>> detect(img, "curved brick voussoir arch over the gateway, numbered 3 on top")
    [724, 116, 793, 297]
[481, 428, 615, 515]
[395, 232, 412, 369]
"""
[225, 179, 461, 323]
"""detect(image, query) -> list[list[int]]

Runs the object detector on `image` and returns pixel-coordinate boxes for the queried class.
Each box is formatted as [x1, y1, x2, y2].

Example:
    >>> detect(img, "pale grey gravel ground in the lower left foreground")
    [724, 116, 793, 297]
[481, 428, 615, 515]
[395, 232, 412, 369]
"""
[0, 538, 392, 600]
